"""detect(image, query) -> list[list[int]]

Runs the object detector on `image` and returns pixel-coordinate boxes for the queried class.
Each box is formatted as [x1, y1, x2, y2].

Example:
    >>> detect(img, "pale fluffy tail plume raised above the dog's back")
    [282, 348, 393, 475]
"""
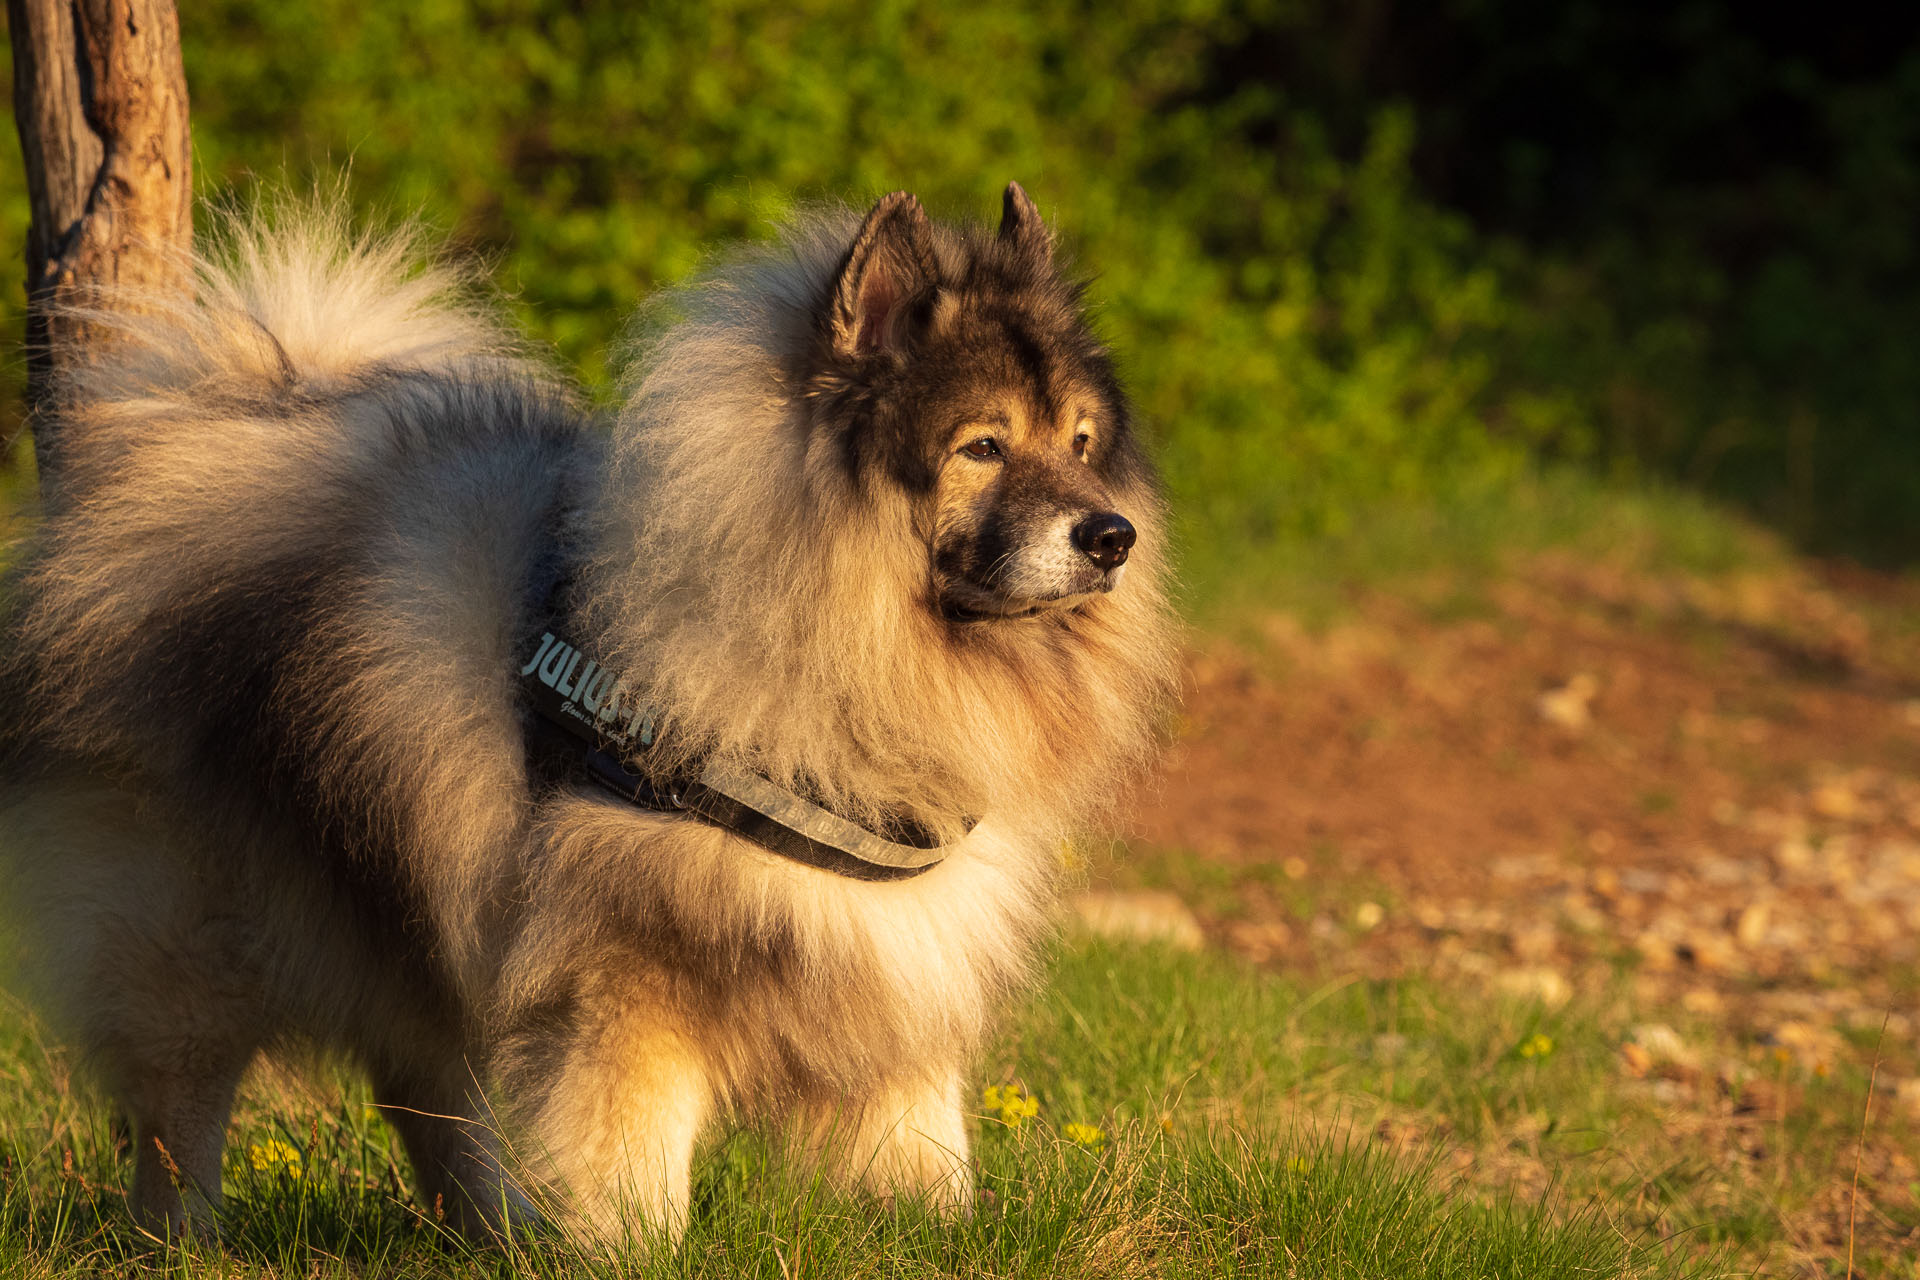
[56, 196, 524, 411]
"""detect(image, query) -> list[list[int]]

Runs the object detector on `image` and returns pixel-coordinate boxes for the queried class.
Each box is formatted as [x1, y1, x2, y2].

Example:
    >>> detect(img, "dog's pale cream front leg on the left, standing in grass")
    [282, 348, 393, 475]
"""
[518, 1019, 712, 1247]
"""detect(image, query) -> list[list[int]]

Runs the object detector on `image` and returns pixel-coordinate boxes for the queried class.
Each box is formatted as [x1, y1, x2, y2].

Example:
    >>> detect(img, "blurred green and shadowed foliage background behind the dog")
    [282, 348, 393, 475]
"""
[0, 0, 1920, 576]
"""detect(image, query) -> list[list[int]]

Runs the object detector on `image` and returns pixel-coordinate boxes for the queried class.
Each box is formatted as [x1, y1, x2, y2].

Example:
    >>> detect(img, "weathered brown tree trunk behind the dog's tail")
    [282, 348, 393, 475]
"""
[8, 0, 194, 487]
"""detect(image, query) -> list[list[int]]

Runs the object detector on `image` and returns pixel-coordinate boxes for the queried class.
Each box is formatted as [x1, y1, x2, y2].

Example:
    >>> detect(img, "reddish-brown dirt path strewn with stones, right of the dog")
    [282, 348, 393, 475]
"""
[1096, 560, 1920, 1255]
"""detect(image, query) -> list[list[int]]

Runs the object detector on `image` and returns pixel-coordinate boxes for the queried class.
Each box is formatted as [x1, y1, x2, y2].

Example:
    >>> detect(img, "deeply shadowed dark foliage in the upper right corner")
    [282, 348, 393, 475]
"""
[1212, 0, 1920, 560]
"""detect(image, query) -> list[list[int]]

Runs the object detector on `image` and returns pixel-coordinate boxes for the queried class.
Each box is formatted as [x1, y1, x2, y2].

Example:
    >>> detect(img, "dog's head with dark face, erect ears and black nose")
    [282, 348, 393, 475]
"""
[806, 182, 1154, 622]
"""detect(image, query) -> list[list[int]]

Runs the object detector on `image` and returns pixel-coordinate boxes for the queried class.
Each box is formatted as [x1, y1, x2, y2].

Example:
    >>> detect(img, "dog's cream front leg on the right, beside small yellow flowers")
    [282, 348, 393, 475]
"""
[810, 1073, 973, 1213]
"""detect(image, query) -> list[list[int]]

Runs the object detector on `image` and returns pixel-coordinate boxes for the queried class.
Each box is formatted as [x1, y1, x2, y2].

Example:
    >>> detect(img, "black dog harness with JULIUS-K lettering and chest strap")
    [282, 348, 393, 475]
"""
[516, 549, 972, 881]
